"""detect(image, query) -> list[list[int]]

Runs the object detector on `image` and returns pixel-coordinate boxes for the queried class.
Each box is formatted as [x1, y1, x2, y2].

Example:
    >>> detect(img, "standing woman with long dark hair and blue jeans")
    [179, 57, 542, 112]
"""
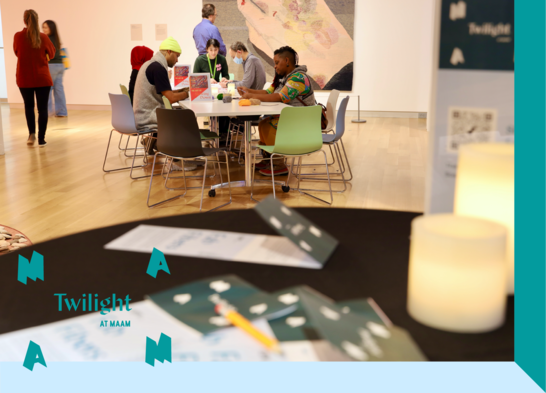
[42, 20, 68, 117]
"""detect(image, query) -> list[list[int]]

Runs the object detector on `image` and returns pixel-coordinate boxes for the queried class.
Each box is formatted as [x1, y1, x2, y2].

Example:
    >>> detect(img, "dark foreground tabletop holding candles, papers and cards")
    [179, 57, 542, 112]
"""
[0, 209, 514, 361]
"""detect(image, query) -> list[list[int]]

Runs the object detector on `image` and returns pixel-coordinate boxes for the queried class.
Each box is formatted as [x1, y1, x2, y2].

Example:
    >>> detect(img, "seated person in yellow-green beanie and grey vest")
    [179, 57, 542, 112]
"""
[133, 37, 197, 171]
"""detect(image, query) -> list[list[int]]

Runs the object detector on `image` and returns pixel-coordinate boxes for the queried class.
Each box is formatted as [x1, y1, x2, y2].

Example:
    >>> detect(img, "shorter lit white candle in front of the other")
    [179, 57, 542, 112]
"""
[408, 214, 507, 333]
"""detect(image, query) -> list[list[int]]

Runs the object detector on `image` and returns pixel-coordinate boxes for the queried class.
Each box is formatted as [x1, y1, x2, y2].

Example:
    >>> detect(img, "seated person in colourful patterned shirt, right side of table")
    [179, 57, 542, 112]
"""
[238, 46, 316, 176]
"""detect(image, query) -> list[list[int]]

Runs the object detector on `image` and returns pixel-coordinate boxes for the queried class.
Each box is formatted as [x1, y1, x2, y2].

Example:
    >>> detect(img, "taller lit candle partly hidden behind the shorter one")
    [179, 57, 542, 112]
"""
[454, 143, 514, 294]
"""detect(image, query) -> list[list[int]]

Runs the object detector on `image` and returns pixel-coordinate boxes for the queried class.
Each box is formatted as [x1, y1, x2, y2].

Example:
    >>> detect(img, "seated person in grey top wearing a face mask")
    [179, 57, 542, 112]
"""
[220, 41, 265, 89]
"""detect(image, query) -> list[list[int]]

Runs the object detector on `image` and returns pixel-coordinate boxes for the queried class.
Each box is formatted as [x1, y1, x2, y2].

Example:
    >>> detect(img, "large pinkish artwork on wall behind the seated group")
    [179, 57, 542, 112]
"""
[210, 0, 355, 91]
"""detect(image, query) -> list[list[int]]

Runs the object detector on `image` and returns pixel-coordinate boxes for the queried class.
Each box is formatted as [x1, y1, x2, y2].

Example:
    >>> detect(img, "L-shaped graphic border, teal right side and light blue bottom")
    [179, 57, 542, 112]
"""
[0, 0, 536, 393]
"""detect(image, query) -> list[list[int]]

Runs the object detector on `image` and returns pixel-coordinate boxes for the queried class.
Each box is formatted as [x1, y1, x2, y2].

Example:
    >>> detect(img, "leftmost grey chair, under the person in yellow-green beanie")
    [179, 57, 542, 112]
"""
[102, 94, 154, 180]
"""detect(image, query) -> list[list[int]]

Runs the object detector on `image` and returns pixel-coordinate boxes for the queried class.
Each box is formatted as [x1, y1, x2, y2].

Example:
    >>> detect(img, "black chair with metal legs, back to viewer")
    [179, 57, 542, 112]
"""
[147, 108, 231, 211]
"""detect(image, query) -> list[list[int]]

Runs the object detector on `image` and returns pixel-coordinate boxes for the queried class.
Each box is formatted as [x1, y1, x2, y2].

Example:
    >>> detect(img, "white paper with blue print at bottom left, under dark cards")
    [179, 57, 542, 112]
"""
[0, 300, 318, 362]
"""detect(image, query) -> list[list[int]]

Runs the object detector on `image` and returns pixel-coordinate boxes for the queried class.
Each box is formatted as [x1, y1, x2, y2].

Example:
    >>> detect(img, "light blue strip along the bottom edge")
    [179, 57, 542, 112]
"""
[0, 361, 542, 393]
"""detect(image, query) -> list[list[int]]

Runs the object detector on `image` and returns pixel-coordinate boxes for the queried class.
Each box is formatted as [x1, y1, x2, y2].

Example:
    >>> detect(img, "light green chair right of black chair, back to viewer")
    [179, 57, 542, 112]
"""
[250, 105, 334, 205]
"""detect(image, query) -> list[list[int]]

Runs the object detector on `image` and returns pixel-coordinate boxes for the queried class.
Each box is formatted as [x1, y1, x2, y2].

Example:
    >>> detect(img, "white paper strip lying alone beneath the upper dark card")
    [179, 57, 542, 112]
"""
[104, 225, 322, 269]
